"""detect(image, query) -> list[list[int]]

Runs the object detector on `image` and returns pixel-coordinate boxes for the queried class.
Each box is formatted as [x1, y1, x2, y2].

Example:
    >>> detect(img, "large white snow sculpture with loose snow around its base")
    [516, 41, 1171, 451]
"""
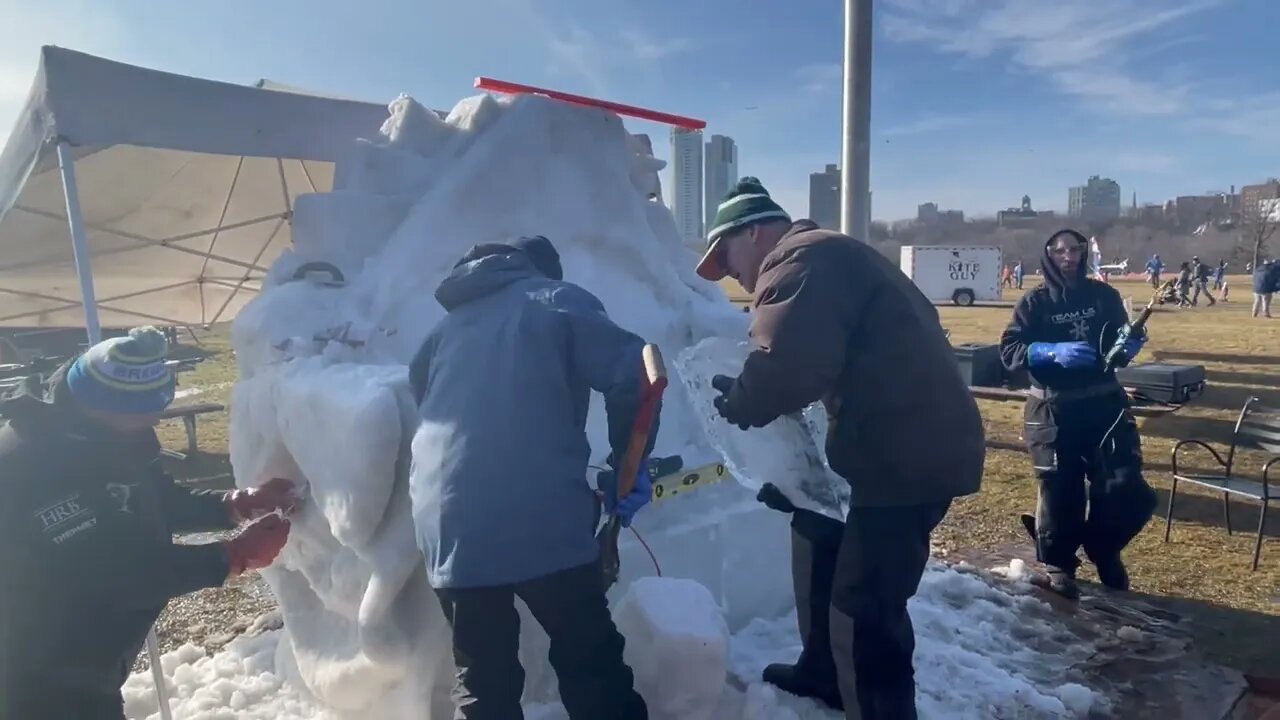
[128, 96, 1091, 720]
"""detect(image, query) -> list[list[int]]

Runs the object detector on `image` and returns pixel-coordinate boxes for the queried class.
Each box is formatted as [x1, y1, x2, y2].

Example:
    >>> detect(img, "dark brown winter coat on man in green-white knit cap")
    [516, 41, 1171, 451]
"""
[728, 220, 986, 507]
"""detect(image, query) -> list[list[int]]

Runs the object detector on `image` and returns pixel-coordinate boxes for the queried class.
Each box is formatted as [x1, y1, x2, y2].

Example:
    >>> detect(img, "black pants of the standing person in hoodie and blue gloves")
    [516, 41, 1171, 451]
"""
[1023, 388, 1156, 570]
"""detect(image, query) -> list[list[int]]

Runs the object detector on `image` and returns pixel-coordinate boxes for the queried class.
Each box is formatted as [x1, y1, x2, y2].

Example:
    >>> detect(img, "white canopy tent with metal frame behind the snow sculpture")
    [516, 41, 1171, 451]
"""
[0, 47, 387, 341]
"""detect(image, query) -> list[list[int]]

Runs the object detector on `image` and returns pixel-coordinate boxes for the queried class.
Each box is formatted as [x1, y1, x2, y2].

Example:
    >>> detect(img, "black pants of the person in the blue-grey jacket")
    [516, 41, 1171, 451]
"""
[436, 562, 649, 720]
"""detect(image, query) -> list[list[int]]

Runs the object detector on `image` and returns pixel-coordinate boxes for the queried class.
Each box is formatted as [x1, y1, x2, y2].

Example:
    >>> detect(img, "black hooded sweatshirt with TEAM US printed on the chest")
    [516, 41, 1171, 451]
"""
[1000, 229, 1129, 391]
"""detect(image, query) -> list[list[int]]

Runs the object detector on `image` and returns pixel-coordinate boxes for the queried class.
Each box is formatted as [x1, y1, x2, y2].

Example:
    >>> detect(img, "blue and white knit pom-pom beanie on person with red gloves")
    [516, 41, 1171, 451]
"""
[67, 327, 177, 415]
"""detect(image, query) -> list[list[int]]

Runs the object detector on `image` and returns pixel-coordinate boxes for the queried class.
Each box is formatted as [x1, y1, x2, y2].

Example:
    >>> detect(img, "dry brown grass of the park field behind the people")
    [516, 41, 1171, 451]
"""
[161, 278, 1280, 675]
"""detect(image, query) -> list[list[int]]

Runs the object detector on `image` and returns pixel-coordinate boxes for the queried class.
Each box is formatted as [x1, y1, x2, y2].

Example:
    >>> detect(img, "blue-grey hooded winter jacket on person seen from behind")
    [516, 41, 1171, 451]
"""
[410, 247, 644, 588]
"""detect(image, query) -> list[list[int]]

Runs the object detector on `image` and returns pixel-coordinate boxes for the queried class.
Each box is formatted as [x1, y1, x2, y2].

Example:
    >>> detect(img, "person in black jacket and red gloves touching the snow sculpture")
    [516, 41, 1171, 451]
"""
[0, 328, 294, 720]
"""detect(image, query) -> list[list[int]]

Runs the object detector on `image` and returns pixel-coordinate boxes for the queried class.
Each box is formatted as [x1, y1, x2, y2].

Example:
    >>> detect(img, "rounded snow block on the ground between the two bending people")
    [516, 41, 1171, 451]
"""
[614, 578, 728, 720]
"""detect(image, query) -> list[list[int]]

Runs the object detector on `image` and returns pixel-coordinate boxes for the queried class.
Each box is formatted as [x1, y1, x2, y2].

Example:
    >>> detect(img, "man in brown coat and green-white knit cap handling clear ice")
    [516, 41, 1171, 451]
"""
[698, 178, 986, 720]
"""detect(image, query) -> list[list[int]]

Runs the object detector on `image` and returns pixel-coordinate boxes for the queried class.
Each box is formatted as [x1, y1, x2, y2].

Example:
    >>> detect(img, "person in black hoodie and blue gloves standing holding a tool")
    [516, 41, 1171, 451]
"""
[1000, 229, 1156, 598]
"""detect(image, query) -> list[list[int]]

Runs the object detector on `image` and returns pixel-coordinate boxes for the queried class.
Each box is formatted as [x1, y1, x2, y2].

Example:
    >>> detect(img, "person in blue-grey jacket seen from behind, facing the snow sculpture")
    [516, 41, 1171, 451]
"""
[410, 236, 653, 720]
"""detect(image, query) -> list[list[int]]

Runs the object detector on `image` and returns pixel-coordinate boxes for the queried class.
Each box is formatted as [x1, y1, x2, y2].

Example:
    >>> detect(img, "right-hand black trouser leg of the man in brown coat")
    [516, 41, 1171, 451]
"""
[831, 501, 951, 720]
